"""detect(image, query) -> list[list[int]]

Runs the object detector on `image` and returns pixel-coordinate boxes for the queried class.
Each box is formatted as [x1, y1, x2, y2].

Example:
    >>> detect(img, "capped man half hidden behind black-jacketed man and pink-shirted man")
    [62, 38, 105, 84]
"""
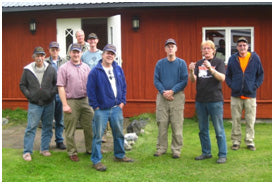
[45, 41, 66, 150]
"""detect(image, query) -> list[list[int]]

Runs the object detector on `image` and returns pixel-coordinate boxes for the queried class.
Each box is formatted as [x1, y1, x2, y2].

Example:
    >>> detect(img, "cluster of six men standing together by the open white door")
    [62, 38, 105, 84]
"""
[20, 30, 133, 171]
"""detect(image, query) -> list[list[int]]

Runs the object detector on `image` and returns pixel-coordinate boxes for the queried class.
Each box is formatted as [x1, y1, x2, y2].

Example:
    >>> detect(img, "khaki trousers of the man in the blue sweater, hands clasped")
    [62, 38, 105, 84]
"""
[156, 92, 185, 155]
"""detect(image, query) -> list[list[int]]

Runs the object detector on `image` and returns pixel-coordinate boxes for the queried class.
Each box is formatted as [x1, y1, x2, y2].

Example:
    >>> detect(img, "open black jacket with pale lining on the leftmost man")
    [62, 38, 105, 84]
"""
[19, 62, 57, 106]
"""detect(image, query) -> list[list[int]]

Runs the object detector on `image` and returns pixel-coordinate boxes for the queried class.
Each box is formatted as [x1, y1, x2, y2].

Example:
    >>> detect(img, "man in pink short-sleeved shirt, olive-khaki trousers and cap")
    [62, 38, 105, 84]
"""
[57, 43, 93, 162]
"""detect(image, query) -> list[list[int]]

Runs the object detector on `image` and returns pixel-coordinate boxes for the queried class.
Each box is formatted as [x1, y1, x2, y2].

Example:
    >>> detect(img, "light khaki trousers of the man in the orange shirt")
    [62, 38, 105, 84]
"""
[231, 97, 257, 146]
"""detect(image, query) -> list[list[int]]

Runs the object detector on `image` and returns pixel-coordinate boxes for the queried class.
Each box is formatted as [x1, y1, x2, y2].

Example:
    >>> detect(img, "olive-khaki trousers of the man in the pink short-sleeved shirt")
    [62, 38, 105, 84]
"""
[64, 97, 94, 156]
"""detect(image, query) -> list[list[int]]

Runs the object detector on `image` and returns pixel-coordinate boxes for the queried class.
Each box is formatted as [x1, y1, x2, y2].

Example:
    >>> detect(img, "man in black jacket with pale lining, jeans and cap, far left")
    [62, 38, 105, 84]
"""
[20, 47, 57, 161]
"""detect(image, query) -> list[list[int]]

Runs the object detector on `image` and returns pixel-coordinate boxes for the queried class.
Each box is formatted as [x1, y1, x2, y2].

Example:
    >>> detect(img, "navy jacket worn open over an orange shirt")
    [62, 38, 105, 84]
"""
[225, 52, 264, 98]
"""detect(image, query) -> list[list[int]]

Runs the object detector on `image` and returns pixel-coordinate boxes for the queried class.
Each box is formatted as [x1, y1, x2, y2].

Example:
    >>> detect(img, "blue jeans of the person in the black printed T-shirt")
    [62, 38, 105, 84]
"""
[195, 101, 227, 157]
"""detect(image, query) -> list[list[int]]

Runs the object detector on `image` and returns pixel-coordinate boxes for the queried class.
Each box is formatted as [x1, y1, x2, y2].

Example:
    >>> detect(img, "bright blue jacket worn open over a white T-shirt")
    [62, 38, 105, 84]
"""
[87, 59, 127, 109]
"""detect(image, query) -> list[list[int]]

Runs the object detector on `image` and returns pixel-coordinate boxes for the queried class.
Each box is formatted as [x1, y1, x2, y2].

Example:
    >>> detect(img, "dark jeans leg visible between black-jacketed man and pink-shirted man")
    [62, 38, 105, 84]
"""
[54, 94, 64, 143]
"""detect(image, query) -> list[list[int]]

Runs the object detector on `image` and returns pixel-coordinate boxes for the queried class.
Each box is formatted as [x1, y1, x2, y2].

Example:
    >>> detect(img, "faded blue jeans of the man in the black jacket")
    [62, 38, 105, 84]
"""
[24, 102, 54, 154]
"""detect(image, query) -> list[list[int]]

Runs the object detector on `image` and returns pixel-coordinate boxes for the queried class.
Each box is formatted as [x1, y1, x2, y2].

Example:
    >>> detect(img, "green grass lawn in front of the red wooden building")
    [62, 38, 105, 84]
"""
[2, 111, 272, 182]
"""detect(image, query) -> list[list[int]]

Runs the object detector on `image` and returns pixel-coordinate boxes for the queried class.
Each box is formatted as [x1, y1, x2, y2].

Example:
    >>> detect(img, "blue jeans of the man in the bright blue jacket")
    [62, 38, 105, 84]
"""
[91, 106, 125, 164]
